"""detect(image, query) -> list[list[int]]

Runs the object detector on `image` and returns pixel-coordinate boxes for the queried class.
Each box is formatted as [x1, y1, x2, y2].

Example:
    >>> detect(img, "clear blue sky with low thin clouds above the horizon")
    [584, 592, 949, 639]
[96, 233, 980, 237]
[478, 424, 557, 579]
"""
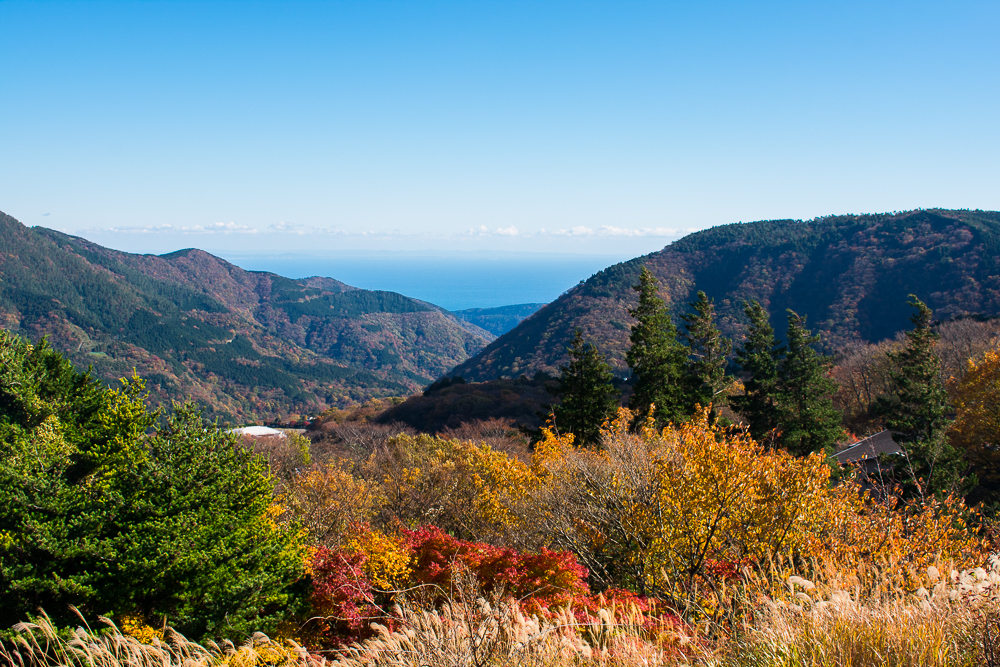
[0, 0, 1000, 258]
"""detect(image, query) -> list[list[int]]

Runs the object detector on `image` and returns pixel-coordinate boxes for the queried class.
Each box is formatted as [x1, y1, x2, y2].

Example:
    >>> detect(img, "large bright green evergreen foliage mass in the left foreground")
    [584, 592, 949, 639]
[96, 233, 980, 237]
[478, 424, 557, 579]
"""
[0, 331, 302, 637]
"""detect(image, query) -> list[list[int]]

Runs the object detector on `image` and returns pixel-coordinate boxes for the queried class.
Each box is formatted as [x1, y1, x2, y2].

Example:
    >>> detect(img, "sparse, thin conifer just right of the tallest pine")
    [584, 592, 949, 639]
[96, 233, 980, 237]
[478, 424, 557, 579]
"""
[681, 291, 733, 407]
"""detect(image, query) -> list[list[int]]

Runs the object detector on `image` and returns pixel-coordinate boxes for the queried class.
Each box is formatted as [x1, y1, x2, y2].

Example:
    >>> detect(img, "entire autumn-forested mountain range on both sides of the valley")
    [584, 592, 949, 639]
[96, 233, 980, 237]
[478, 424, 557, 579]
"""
[9, 209, 1000, 421]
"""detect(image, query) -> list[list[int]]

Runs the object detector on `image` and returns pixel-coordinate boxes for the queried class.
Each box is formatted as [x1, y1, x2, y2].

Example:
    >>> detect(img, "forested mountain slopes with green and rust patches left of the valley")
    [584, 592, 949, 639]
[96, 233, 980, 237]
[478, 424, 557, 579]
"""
[0, 213, 493, 420]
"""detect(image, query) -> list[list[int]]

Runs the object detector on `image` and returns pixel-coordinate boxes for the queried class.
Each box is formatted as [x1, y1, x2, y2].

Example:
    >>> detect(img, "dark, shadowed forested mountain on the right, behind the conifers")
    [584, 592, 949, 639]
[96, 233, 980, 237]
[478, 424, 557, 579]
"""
[450, 209, 1000, 381]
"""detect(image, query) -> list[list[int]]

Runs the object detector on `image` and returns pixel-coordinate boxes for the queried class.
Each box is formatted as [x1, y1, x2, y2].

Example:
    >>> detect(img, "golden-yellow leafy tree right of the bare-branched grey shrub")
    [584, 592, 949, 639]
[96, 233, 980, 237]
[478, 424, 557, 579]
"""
[650, 410, 829, 583]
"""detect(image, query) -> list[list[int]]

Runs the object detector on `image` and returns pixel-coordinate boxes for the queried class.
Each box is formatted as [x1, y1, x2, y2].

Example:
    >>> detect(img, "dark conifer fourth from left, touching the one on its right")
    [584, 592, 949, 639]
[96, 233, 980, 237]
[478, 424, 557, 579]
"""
[729, 301, 778, 442]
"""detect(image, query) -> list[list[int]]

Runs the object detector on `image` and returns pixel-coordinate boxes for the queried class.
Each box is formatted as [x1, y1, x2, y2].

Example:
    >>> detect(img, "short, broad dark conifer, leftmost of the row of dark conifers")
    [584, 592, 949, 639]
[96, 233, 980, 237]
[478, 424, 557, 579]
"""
[553, 329, 619, 445]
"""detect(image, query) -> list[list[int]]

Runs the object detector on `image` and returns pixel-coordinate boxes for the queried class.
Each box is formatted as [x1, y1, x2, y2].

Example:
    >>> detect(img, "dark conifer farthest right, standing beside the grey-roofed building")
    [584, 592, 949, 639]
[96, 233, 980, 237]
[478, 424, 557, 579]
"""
[878, 294, 963, 495]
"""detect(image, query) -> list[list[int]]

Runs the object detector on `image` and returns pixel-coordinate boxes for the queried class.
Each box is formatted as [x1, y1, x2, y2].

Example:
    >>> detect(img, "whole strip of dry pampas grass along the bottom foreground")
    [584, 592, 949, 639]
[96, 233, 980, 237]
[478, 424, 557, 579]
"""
[9, 556, 1000, 667]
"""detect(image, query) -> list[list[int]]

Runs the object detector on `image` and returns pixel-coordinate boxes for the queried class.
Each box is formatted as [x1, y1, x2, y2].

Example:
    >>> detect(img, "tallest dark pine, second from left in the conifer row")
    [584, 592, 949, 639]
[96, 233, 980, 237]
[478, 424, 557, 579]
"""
[625, 267, 693, 422]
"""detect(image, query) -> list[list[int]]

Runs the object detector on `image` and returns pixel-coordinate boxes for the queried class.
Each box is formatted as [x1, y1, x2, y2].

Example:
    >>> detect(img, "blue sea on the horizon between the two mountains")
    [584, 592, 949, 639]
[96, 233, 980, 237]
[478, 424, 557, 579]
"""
[216, 252, 630, 310]
